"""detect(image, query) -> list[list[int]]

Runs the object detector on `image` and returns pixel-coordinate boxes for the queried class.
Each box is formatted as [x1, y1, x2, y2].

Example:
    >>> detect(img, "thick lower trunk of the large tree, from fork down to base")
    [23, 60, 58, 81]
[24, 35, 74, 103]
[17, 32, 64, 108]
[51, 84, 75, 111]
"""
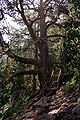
[39, 43, 51, 89]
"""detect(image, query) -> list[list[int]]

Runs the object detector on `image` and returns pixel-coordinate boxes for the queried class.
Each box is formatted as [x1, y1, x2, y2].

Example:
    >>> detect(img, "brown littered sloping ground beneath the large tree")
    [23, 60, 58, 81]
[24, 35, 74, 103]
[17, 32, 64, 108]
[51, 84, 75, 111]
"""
[11, 85, 80, 120]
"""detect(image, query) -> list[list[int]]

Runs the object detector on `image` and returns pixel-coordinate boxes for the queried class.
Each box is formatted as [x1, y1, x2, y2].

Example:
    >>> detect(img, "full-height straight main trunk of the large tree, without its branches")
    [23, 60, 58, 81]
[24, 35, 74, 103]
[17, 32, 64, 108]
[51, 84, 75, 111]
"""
[39, 0, 51, 89]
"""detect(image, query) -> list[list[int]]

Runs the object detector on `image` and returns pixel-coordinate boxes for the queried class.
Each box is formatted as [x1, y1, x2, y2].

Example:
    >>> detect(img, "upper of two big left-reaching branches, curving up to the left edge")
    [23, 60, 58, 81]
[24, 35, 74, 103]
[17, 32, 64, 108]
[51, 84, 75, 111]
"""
[0, 32, 40, 65]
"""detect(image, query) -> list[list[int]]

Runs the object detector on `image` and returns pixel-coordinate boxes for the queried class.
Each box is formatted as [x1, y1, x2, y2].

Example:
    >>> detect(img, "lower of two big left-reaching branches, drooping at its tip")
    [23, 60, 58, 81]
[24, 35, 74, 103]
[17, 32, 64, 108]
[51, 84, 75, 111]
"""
[7, 69, 42, 83]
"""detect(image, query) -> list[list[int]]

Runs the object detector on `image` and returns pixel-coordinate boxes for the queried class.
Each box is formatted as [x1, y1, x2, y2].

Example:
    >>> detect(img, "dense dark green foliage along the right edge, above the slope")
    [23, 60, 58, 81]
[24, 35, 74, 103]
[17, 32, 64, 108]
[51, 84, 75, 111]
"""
[61, 0, 80, 74]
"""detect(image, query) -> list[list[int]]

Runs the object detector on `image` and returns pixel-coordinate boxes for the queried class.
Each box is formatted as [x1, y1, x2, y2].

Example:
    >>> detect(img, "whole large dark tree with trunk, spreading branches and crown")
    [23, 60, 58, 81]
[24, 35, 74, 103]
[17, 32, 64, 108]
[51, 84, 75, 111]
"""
[0, 0, 68, 89]
